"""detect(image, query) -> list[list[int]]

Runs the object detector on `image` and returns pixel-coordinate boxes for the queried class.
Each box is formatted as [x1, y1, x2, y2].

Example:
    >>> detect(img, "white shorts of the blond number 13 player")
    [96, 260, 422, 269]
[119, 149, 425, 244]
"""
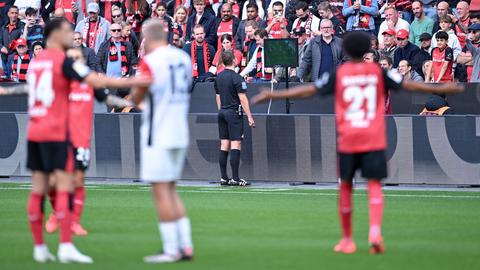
[140, 147, 187, 183]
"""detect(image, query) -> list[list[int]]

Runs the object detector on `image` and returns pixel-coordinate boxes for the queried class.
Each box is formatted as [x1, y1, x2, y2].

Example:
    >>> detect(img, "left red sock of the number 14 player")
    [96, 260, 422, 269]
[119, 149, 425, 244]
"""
[27, 192, 44, 245]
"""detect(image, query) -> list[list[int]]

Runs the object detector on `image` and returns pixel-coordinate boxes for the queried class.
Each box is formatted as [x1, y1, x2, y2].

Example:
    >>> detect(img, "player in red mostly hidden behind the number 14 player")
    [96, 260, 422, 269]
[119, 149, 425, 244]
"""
[45, 48, 132, 236]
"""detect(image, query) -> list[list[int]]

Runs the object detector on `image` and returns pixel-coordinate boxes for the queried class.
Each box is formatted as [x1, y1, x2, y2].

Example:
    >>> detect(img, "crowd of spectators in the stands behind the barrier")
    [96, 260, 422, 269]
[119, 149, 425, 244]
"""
[0, 0, 480, 88]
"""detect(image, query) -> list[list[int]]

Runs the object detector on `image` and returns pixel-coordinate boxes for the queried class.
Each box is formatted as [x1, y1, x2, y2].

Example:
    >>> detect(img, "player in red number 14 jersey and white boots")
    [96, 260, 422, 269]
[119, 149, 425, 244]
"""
[0, 18, 140, 263]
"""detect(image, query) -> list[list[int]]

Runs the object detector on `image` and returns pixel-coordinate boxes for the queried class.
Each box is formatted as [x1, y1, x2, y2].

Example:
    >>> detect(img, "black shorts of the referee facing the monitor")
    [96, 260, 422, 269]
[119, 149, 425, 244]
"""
[218, 109, 243, 141]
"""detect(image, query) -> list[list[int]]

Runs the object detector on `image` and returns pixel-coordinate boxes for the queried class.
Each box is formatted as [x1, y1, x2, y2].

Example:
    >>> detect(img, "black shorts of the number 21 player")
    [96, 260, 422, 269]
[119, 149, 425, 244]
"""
[338, 150, 387, 181]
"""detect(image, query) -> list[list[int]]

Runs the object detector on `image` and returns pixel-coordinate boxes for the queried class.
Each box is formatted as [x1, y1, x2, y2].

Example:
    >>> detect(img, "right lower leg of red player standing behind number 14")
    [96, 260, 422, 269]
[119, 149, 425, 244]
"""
[72, 169, 88, 236]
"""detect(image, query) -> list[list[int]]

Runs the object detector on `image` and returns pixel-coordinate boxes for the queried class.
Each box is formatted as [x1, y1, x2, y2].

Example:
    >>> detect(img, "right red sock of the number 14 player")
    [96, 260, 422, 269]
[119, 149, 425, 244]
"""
[55, 191, 72, 243]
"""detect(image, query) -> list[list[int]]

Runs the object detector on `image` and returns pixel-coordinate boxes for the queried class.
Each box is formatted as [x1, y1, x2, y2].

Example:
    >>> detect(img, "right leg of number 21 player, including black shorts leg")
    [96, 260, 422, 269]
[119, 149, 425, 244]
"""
[362, 151, 387, 254]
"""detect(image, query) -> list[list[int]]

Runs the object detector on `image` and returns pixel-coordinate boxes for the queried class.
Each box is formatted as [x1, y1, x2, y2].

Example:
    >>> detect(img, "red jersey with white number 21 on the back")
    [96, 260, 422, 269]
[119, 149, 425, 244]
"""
[315, 62, 402, 154]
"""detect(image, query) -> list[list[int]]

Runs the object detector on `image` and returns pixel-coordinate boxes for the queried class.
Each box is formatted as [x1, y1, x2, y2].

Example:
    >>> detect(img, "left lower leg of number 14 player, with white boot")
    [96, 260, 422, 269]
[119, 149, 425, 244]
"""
[27, 171, 55, 263]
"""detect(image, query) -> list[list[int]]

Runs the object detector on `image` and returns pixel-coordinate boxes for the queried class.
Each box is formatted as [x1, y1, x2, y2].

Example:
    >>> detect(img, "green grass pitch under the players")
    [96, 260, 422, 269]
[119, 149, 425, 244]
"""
[0, 184, 480, 270]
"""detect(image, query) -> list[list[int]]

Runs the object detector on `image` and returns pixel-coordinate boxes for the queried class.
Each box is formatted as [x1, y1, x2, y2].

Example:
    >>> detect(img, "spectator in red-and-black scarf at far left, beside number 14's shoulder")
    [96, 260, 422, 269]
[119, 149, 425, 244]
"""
[6, 38, 30, 82]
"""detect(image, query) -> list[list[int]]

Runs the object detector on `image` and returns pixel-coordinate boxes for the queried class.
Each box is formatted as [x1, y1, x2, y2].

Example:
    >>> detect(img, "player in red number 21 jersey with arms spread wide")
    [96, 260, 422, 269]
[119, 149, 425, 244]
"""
[253, 32, 463, 254]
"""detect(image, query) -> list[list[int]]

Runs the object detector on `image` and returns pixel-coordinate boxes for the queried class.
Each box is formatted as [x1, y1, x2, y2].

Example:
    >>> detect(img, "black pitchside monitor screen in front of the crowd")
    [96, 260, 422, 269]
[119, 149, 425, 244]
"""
[264, 38, 298, 67]
